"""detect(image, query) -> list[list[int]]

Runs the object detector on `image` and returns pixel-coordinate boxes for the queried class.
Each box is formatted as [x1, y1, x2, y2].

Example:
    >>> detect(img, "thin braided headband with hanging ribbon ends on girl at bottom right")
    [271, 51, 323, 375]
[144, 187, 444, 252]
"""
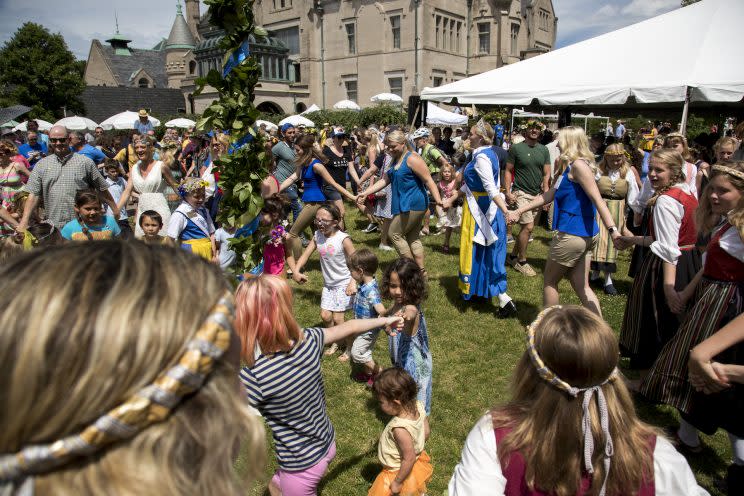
[527, 305, 617, 496]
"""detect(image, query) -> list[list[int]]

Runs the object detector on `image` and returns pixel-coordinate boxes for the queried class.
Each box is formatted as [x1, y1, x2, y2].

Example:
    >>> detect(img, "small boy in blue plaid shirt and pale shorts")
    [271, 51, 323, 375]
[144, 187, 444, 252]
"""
[348, 248, 385, 387]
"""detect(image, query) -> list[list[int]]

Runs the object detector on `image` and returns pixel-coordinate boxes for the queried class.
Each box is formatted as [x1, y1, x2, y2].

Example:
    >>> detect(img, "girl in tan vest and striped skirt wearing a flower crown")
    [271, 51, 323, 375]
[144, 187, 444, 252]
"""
[591, 143, 638, 296]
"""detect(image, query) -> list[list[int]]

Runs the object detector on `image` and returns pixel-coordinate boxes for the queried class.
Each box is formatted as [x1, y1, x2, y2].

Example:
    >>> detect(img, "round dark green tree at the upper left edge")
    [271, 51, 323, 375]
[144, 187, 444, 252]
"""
[0, 22, 85, 121]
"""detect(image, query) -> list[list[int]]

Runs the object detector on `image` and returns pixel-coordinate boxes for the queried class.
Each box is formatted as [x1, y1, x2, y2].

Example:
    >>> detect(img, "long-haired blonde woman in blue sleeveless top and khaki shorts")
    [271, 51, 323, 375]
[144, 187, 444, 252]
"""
[507, 126, 621, 316]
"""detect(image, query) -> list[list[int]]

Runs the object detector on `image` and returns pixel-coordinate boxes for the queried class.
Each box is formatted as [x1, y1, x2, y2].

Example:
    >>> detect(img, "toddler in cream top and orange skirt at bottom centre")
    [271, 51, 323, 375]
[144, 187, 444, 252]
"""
[367, 367, 434, 496]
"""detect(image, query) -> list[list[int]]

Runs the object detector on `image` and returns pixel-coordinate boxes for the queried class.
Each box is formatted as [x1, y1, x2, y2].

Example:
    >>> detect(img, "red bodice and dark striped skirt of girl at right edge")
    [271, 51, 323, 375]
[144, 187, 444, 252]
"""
[641, 222, 744, 437]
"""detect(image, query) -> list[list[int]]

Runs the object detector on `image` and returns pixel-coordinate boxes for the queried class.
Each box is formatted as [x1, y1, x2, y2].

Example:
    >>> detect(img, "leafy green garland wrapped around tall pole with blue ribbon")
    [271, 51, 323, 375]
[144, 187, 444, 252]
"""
[195, 0, 269, 271]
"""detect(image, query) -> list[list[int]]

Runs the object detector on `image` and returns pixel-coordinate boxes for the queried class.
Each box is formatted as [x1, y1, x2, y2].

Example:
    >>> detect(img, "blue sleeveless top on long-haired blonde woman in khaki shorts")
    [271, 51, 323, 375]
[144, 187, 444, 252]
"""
[553, 165, 599, 238]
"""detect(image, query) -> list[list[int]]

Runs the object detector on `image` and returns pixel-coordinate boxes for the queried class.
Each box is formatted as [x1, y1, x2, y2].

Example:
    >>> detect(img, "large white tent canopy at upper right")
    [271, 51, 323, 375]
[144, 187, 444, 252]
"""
[421, 0, 744, 107]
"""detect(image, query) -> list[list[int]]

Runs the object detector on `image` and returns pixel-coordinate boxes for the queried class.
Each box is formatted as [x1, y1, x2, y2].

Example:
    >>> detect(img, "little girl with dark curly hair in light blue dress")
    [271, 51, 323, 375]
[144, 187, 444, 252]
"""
[382, 257, 432, 415]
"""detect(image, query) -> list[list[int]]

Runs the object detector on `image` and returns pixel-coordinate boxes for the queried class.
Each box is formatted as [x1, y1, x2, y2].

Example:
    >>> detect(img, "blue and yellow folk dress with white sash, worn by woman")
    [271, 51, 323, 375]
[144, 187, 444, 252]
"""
[458, 146, 506, 300]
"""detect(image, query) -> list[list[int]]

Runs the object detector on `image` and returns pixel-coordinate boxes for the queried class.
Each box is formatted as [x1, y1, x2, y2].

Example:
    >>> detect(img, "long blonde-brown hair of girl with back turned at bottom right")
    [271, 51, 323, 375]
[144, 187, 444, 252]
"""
[492, 306, 656, 496]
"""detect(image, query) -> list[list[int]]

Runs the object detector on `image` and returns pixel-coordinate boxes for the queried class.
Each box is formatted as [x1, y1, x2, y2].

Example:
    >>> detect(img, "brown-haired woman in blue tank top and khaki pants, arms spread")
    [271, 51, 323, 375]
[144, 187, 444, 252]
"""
[279, 134, 355, 260]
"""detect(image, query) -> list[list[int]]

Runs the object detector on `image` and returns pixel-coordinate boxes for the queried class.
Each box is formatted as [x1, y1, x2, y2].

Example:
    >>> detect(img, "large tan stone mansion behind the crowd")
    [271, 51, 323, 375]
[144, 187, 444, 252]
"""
[85, 0, 558, 118]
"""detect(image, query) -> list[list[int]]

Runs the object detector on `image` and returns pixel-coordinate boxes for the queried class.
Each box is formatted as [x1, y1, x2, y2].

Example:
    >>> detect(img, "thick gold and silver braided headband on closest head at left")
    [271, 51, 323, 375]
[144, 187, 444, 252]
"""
[0, 291, 234, 486]
